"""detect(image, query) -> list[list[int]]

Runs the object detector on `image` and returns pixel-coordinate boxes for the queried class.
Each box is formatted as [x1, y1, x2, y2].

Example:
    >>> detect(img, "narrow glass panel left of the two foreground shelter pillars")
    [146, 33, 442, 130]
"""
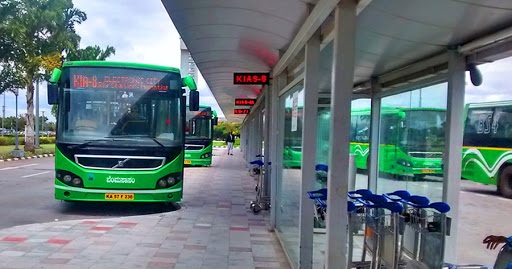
[276, 82, 304, 267]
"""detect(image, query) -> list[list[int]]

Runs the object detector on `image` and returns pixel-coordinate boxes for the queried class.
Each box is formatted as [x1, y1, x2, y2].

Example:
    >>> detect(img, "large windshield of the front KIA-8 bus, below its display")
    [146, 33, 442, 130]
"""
[58, 73, 183, 145]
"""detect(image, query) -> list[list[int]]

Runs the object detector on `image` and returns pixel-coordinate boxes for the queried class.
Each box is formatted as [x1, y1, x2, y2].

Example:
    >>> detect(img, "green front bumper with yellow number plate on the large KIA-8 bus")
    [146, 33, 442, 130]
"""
[55, 184, 182, 202]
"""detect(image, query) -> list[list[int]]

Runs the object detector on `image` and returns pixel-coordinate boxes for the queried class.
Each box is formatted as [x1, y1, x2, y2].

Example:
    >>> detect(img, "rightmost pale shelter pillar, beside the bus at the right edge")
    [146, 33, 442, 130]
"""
[443, 50, 466, 263]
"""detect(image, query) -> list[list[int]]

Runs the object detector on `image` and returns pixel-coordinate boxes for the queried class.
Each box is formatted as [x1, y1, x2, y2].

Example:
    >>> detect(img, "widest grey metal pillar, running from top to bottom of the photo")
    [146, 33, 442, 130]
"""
[325, 0, 357, 269]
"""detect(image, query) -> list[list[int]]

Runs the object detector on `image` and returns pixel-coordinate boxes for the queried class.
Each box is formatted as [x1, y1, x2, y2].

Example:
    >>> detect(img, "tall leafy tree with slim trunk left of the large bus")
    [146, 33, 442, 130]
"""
[3, 0, 87, 151]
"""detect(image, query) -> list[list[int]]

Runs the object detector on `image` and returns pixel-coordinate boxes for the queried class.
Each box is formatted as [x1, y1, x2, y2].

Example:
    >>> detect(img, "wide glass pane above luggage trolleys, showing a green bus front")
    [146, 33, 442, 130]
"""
[377, 83, 447, 202]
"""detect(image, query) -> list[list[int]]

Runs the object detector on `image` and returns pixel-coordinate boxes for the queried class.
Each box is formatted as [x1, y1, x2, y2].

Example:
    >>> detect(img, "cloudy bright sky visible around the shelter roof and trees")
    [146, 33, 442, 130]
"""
[0, 0, 512, 121]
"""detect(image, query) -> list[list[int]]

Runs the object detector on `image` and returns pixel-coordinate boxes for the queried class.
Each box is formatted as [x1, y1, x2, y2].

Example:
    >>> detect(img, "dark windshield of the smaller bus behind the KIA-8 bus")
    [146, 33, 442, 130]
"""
[185, 110, 212, 139]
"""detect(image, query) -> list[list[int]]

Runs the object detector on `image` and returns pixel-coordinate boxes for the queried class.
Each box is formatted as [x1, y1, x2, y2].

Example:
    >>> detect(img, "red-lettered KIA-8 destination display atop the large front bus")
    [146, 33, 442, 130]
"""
[70, 67, 181, 91]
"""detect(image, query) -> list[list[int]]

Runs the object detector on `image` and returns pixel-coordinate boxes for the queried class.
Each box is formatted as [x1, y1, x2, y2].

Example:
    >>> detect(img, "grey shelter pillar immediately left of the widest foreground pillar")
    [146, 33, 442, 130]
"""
[299, 30, 320, 269]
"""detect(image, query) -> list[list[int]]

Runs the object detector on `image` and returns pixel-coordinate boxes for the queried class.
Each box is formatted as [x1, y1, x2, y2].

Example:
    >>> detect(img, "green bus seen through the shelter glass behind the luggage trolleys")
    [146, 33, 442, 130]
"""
[350, 107, 446, 179]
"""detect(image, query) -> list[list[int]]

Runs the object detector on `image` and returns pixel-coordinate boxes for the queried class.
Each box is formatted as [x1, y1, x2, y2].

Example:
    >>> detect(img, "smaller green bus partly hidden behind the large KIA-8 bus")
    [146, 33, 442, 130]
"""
[184, 106, 218, 166]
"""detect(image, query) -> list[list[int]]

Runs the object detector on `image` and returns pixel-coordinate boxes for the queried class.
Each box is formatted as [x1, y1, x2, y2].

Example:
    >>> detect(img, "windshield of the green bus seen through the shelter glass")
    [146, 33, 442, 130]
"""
[400, 110, 446, 152]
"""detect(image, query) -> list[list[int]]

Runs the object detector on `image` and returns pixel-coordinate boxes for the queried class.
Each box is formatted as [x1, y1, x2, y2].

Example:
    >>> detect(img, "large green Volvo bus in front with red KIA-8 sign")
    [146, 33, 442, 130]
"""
[48, 61, 199, 202]
